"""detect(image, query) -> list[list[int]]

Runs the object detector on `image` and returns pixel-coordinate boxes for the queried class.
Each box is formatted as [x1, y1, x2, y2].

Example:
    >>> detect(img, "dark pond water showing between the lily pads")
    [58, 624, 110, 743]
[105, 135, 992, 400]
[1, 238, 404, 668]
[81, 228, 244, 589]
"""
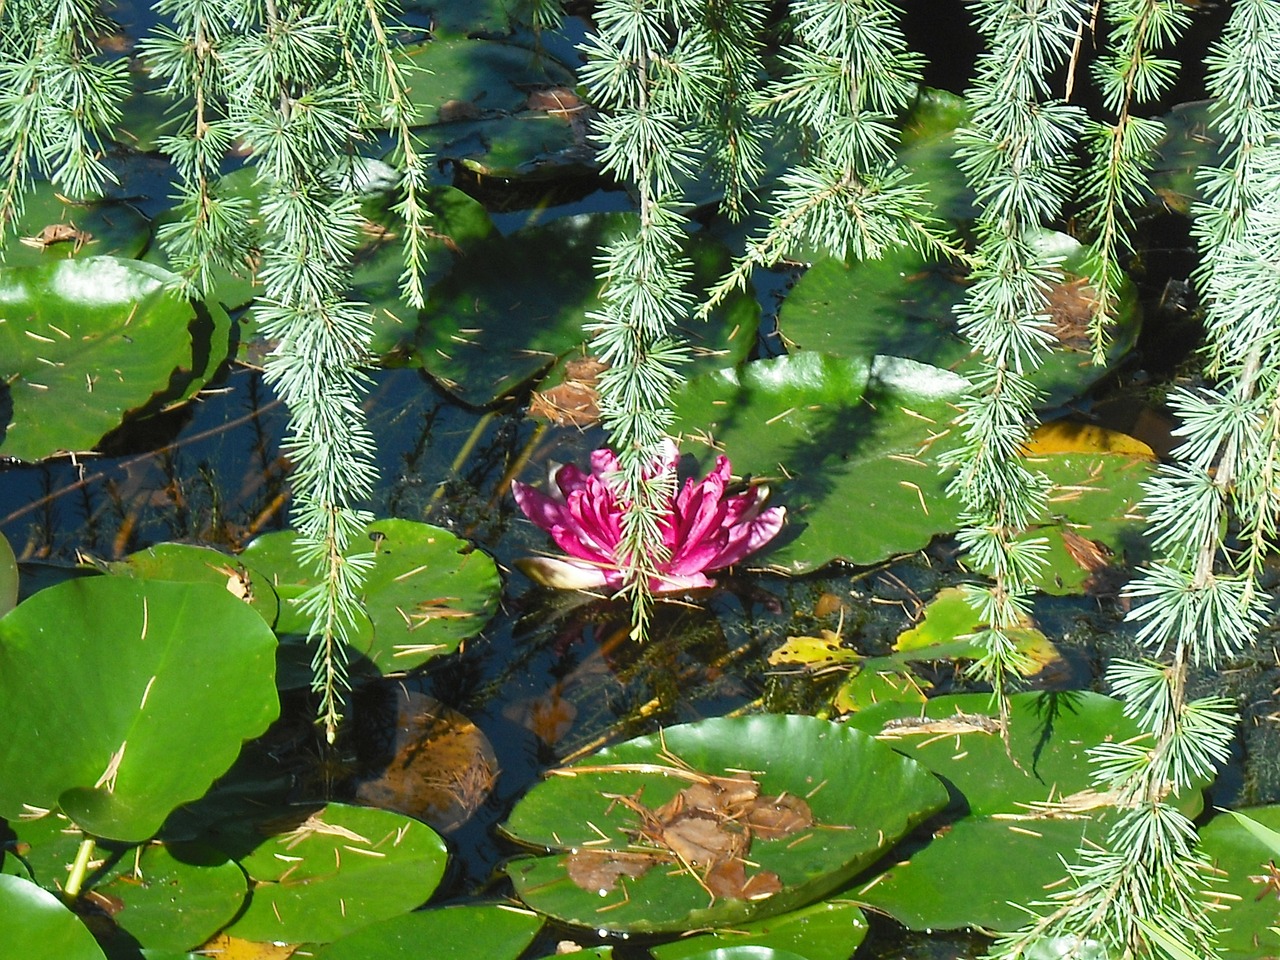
[0, 3, 1280, 960]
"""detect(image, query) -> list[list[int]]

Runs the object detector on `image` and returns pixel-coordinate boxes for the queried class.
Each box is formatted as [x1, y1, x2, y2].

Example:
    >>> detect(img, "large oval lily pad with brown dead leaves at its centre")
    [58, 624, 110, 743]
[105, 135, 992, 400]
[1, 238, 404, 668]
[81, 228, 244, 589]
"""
[504, 716, 946, 932]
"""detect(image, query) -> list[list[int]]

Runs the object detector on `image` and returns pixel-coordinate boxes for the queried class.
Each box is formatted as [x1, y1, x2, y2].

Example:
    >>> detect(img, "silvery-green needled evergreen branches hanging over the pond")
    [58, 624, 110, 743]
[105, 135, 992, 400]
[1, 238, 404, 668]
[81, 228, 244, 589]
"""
[0, 0, 1280, 960]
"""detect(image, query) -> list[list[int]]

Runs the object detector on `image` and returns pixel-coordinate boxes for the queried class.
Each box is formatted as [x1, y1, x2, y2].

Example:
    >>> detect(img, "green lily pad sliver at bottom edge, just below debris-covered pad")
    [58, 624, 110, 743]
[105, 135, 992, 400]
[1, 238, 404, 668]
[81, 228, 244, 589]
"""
[649, 900, 868, 960]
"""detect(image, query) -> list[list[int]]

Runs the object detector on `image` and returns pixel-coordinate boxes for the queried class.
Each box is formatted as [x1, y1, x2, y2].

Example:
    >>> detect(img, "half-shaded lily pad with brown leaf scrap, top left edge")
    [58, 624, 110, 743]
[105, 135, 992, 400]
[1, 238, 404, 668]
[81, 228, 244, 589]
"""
[4, 182, 151, 266]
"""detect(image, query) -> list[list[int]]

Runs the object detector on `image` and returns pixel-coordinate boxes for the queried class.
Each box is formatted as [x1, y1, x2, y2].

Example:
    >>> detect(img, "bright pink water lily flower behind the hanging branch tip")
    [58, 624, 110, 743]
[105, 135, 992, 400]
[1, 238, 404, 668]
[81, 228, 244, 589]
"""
[511, 444, 786, 593]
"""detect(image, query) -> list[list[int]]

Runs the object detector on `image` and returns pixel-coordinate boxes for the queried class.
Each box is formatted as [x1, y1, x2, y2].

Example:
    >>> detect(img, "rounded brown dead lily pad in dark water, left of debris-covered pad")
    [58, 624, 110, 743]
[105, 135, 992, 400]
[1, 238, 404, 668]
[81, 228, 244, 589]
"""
[356, 689, 498, 832]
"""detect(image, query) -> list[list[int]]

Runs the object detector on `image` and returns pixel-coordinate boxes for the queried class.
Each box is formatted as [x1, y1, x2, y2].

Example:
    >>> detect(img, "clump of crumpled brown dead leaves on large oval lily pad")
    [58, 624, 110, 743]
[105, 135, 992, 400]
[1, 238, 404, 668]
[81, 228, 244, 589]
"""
[564, 771, 814, 902]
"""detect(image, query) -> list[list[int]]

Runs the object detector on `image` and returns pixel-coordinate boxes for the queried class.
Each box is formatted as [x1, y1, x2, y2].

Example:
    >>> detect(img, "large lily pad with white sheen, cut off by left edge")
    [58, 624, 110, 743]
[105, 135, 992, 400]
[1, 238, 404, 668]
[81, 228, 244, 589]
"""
[0, 257, 229, 460]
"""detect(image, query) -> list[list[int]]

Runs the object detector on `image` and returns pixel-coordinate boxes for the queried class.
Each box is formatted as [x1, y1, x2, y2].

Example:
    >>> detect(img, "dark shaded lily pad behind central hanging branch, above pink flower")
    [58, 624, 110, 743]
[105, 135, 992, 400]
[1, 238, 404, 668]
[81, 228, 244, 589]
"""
[416, 214, 759, 407]
